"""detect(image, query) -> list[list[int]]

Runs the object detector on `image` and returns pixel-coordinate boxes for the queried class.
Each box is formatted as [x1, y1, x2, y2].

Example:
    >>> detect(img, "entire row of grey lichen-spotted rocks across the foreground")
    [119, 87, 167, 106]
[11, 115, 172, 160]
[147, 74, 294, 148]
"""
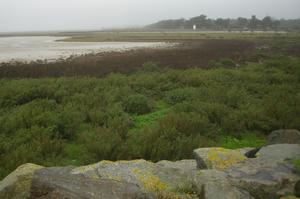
[0, 144, 300, 199]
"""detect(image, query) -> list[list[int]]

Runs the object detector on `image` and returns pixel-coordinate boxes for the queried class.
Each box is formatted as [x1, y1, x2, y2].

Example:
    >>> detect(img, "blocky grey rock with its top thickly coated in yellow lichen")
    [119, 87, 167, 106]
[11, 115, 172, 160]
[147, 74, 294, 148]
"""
[194, 147, 246, 169]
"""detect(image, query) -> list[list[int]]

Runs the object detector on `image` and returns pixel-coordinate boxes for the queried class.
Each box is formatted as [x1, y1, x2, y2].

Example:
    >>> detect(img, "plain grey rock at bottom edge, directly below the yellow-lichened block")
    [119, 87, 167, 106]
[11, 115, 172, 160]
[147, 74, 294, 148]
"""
[193, 170, 253, 199]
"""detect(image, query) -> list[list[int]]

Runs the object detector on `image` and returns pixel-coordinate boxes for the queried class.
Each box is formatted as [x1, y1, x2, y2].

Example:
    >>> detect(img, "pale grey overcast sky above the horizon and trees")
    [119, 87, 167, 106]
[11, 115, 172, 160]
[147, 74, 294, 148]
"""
[0, 0, 300, 32]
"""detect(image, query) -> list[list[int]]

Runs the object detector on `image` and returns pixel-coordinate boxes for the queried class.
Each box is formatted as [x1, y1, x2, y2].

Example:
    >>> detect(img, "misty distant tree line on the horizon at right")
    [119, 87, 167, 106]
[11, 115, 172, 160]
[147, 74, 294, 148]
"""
[146, 15, 300, 31]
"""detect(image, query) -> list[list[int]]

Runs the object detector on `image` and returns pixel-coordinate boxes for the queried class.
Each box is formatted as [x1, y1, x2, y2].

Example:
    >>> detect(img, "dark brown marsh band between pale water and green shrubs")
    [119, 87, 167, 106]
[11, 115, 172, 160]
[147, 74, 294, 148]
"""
[0, 40, 256, 78]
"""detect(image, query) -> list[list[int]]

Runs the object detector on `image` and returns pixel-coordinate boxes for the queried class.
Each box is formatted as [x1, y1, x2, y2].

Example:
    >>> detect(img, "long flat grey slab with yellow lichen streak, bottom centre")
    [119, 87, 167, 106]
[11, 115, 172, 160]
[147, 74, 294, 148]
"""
[71, 160, 195, 195]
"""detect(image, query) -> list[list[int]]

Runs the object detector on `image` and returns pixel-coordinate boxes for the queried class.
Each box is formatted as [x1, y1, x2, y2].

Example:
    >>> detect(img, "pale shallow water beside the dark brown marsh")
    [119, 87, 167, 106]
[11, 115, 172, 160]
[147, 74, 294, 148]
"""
[0, 36, 167, 62]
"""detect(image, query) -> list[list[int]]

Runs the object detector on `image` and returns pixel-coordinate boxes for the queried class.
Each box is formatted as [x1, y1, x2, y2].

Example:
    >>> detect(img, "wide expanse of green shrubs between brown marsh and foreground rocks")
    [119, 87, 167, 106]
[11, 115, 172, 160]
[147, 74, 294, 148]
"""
[0, 53, 300, 177]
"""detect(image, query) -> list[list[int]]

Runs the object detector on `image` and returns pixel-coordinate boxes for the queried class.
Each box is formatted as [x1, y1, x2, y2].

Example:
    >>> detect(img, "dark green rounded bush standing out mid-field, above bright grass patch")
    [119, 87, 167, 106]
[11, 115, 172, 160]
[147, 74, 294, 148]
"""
[124, 94, 152, 115]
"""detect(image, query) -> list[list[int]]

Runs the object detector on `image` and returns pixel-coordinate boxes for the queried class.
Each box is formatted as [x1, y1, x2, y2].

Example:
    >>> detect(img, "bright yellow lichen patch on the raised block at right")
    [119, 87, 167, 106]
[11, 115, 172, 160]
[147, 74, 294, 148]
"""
[207, 148, 246, 169]
